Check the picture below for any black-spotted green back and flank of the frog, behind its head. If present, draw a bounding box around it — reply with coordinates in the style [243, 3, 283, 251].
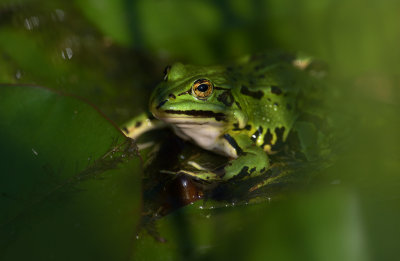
[228, 53, 318, 152]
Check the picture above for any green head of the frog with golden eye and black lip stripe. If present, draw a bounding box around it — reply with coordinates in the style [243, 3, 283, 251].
[150, 63, 247, 128]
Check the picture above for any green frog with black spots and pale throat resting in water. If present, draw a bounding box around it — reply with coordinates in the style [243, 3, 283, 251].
[122, 52, 324, 188]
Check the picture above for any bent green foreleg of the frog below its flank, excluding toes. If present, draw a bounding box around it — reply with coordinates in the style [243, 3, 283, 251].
[221, 133, 269, 180]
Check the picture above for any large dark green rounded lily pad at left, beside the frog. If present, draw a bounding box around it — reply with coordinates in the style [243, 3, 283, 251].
[0, 85, 141, 260]
